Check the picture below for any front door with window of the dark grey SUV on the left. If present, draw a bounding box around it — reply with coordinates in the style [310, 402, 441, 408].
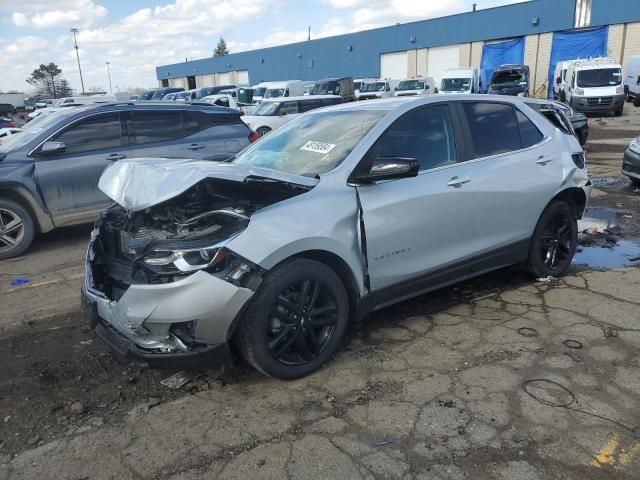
[35, 112, 128, 218]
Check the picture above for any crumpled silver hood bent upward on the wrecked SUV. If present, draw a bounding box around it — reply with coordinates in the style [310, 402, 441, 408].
[98, 158, 318, 212]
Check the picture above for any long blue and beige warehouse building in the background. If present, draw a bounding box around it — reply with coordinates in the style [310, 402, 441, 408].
[156, 0, 640, 96]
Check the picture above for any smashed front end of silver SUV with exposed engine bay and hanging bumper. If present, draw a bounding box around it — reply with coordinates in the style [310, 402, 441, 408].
[83, 159, 314, 368]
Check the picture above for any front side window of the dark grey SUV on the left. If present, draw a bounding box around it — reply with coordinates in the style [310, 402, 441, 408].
[54, 113, 122, 153]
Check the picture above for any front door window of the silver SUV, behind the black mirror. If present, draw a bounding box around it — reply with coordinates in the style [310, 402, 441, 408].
[370, 105, 457, 170]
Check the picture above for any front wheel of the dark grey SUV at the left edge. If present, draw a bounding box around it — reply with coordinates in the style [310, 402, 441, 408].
[0, 199, 35, 260]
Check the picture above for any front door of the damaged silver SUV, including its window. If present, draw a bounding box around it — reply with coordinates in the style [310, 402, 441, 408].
[357, 103, 473, 296]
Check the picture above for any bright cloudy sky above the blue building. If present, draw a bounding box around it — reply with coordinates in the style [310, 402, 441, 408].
[0, 0, 524, 92]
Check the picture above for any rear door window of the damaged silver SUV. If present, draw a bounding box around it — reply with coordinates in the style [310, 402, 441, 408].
[462, 102, 522, 158]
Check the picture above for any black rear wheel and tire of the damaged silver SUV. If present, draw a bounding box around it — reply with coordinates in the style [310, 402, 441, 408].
[527, 201, 578, 278]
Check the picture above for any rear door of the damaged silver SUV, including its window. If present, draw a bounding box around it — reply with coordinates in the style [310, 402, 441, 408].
[459, 101, 562, 271]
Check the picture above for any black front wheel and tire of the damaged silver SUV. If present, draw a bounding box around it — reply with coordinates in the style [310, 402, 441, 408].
[237, 258, 349, 380]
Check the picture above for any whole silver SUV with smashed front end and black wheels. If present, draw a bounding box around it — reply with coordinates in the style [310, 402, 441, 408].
[83, 95, 591, 379]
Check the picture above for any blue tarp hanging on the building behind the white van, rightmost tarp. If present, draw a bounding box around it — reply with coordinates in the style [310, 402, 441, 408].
[549, 26, 613, 98]
